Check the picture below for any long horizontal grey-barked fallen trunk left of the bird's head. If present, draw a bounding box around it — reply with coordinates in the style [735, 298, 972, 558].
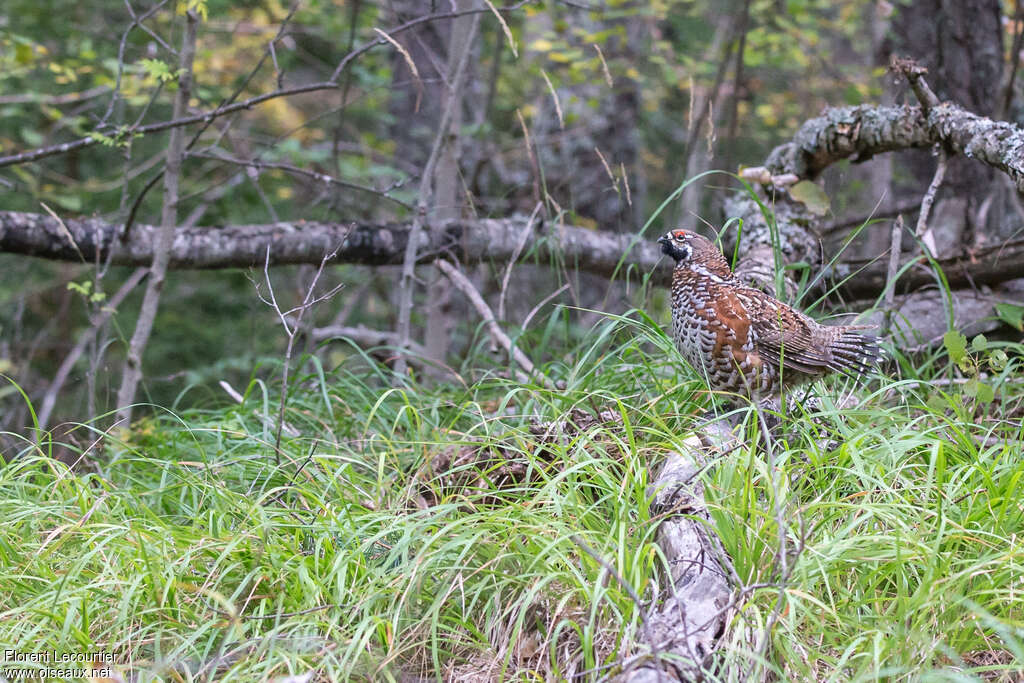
[0, 211, 672, 283]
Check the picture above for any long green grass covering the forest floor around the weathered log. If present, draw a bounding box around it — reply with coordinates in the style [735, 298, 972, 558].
[0, 318, 1024, 681]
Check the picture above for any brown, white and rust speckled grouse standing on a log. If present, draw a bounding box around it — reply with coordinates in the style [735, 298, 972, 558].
[658, 230, 882, 400]
